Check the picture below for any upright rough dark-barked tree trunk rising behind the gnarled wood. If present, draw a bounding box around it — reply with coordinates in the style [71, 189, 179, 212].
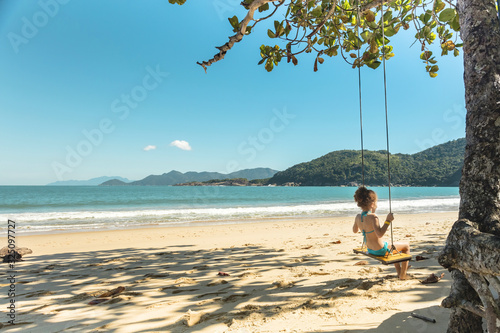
[443, 0, 500, 333]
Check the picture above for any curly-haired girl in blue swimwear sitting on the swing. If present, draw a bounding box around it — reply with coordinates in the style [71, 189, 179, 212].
[352, 186, 410, 280]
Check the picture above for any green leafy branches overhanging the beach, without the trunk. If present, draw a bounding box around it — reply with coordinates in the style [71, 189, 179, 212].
[173, 0, 462, 77]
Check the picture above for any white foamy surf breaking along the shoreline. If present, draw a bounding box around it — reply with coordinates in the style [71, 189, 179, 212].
[0, 197, 459, 231]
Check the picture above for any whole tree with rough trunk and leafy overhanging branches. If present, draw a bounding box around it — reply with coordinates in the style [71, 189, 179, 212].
[169, 0, 500, 333]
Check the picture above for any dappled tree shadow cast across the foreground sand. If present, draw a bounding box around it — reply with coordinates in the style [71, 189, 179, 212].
[0, 231, 450, 332]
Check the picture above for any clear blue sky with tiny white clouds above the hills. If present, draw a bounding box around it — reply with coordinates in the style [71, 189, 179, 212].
[0, 0, 465, 185]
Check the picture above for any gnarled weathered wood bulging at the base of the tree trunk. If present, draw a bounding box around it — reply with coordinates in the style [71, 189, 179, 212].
[438, 219, 500, 332]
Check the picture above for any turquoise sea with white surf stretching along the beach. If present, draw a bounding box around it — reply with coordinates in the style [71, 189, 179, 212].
[0, 186, 459, 234]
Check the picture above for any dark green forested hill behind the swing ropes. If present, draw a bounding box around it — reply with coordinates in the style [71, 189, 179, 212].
[269, 139, 465, 186]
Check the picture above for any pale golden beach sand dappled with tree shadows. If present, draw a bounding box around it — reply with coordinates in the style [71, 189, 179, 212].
[0, 213, 457, 333]
